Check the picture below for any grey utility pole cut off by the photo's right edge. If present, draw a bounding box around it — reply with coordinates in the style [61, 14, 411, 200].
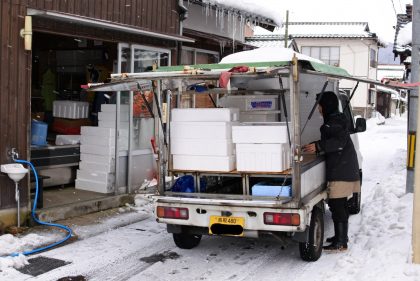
[407, 0, 420, 264]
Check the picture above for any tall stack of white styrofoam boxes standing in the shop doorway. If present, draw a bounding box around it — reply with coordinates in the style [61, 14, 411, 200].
[76, 104, 128, 193]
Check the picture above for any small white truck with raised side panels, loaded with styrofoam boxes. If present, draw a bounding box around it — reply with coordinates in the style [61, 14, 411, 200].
[88, 48, 404, 261]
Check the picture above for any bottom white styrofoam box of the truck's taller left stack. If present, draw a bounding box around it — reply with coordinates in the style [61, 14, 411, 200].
[172, 155, 235, 172]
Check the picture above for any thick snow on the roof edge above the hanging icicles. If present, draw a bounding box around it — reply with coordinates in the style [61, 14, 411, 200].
[202, 0, 286, 26]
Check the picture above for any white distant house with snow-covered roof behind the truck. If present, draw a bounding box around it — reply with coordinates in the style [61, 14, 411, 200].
[281, 22, 382, 117]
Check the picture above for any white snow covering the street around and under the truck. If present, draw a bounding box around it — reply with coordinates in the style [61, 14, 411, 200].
[0, 112, 420, 281]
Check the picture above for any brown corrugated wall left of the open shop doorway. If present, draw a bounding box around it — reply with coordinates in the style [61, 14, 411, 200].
[0, 0, 31, 209]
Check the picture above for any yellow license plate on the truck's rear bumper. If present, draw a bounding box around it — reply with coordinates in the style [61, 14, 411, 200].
[209, 216, 245, 236]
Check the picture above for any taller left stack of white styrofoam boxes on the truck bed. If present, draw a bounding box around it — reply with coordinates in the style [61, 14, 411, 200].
[170, 108, 239, 172]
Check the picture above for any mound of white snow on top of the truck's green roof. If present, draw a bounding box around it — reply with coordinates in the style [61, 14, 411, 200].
[220, 47, 324, 64]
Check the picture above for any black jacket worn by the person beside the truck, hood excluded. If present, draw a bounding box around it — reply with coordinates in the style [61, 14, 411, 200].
[316, 111, 360, 181]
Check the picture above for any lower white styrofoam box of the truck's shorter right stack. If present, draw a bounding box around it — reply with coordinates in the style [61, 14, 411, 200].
[236, 143, 290, 172]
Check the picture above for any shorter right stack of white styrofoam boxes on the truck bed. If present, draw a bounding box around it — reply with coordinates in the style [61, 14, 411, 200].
[232, 122, 290, 172]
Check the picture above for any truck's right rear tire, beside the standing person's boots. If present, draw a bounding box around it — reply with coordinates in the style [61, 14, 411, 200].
[299, 207, 324, 261]
